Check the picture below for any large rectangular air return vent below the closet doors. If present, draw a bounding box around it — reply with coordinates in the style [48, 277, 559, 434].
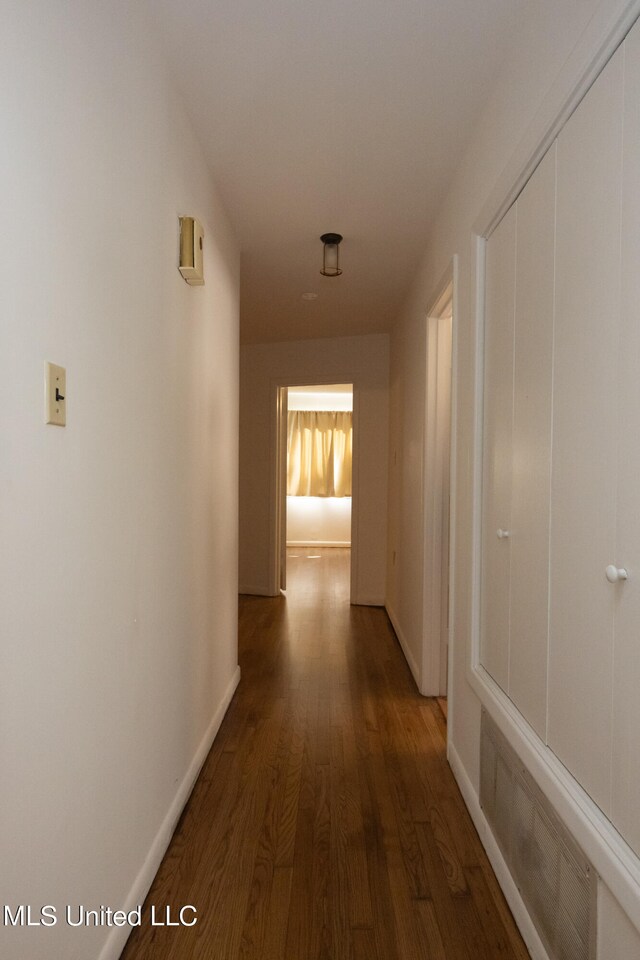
[480, 710, 597, 960]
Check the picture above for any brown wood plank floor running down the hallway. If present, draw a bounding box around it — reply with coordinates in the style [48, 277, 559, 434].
[122, 548, 529, 960]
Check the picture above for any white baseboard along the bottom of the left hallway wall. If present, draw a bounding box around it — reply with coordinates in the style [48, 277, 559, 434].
[98, 667, 240, 960]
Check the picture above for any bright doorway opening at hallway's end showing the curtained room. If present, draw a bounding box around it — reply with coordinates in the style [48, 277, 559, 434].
[278, 383, 354, 597]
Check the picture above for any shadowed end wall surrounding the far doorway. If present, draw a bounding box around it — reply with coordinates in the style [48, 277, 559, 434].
[239, 335, 389, 604]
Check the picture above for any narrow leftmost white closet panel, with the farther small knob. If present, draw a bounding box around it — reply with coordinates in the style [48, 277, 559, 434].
[480, 206, 516, 690]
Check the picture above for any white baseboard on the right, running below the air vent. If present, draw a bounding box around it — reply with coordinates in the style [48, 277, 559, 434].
[447, 742, 549, 960]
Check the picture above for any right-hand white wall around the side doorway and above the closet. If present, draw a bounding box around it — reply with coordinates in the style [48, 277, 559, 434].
[387, 0, 638, 958]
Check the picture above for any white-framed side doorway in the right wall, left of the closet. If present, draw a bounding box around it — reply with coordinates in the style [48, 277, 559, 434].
[421, 263, 455, 704]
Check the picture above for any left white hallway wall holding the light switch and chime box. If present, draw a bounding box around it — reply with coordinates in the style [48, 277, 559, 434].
[0, 0, 239, 960]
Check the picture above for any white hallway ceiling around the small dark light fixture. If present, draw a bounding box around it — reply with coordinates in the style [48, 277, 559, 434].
[152, 0, 531, 342]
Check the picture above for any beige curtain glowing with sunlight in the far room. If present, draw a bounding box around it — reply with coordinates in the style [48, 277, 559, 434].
[287, 410, 353, 497]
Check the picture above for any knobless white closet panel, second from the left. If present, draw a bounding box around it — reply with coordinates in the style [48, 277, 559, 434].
[509, 145, 556, 739]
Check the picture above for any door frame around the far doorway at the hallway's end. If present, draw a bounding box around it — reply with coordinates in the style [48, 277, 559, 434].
[268, 373, 360, 604]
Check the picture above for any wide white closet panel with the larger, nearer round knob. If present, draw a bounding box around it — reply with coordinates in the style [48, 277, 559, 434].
[548, 50, 623, 812]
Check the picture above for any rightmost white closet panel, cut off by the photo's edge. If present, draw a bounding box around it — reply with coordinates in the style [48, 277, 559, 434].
[611, 18, 640, 854]
